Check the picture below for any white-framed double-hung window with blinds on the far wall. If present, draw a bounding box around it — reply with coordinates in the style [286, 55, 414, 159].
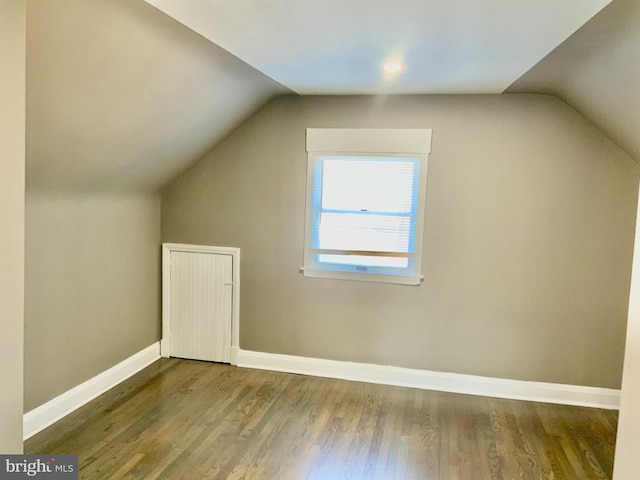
[303, 128, 431, 285]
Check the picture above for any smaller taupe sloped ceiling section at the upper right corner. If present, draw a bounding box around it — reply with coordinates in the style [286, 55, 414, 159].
[507, 0, 640, 163]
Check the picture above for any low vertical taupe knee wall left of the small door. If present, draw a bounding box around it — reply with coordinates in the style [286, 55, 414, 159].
[24, 191, 160, 411]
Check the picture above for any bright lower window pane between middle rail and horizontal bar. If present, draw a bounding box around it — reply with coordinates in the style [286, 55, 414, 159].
[316, 213, 411, 252]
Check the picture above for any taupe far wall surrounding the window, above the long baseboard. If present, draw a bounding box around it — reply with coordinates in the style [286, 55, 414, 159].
[162, 95, 638, 388]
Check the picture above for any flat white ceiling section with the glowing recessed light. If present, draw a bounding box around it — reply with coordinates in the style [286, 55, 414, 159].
[145, 0, 611, 94]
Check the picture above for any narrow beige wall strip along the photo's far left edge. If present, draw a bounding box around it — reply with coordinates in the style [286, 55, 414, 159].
[0, 0, 26, 453]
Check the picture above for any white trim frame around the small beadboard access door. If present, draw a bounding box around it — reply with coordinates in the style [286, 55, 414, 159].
[160, 243, 240, 365]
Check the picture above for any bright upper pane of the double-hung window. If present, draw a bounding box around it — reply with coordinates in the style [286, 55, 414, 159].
[322, 157, 418, 213]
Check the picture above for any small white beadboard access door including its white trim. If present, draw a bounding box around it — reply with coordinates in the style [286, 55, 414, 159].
[161, 244, 240, 363]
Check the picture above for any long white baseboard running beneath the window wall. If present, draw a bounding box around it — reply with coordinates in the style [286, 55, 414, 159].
[237, 350, 620, 410]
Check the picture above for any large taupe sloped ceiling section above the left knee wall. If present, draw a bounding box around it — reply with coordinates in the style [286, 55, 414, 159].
[27, 0, 288, 191]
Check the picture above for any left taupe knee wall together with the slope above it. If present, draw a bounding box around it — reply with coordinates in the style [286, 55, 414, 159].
[20, 0, 287, 411]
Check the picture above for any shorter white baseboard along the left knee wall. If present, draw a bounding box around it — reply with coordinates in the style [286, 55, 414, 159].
[23, 342, 160, 440]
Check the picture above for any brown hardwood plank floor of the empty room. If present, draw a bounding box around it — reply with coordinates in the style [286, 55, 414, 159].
[25, 359, 618, 480]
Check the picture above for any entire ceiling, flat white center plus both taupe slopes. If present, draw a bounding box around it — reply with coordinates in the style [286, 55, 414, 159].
[27, 0, 640, 195]
